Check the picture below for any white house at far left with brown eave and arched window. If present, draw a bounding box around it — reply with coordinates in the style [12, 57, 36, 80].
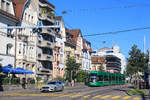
[0, 0, 19, 67]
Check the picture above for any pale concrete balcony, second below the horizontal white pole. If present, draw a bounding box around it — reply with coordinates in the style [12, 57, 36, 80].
[38, 40, 54, 49]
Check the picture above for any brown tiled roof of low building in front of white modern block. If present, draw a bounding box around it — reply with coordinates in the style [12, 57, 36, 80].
[91, 56, 106, 64]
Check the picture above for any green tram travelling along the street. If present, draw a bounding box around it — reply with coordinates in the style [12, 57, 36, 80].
[86, 71, 125, 86]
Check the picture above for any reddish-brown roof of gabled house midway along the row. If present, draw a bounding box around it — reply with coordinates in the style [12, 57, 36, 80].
[66, 29, 82, 44]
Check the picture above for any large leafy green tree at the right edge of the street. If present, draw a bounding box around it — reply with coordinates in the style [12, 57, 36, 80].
[126, 45, 148, 80]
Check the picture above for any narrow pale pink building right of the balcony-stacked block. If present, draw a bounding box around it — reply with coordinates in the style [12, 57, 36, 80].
[52, 16, 65, 79]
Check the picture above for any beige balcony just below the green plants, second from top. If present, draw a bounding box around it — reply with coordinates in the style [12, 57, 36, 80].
[39, 12, 55, 24]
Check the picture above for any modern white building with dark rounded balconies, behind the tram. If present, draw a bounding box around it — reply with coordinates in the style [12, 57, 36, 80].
[92, 46, 126, 73]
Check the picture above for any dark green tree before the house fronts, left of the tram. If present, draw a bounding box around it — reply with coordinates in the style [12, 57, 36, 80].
[66, 57, 81, 82]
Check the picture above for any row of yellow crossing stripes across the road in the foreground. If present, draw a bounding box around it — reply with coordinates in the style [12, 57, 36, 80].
[1, 93, 142, 100]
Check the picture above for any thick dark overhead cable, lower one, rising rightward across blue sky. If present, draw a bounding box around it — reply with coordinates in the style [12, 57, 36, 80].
[83, 27, 150, 37]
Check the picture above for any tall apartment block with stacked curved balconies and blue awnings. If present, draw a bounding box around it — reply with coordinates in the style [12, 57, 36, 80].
[37, 0, 55, 80]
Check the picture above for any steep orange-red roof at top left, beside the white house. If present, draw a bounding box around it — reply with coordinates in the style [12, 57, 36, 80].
[12, 0, 27, 20]
